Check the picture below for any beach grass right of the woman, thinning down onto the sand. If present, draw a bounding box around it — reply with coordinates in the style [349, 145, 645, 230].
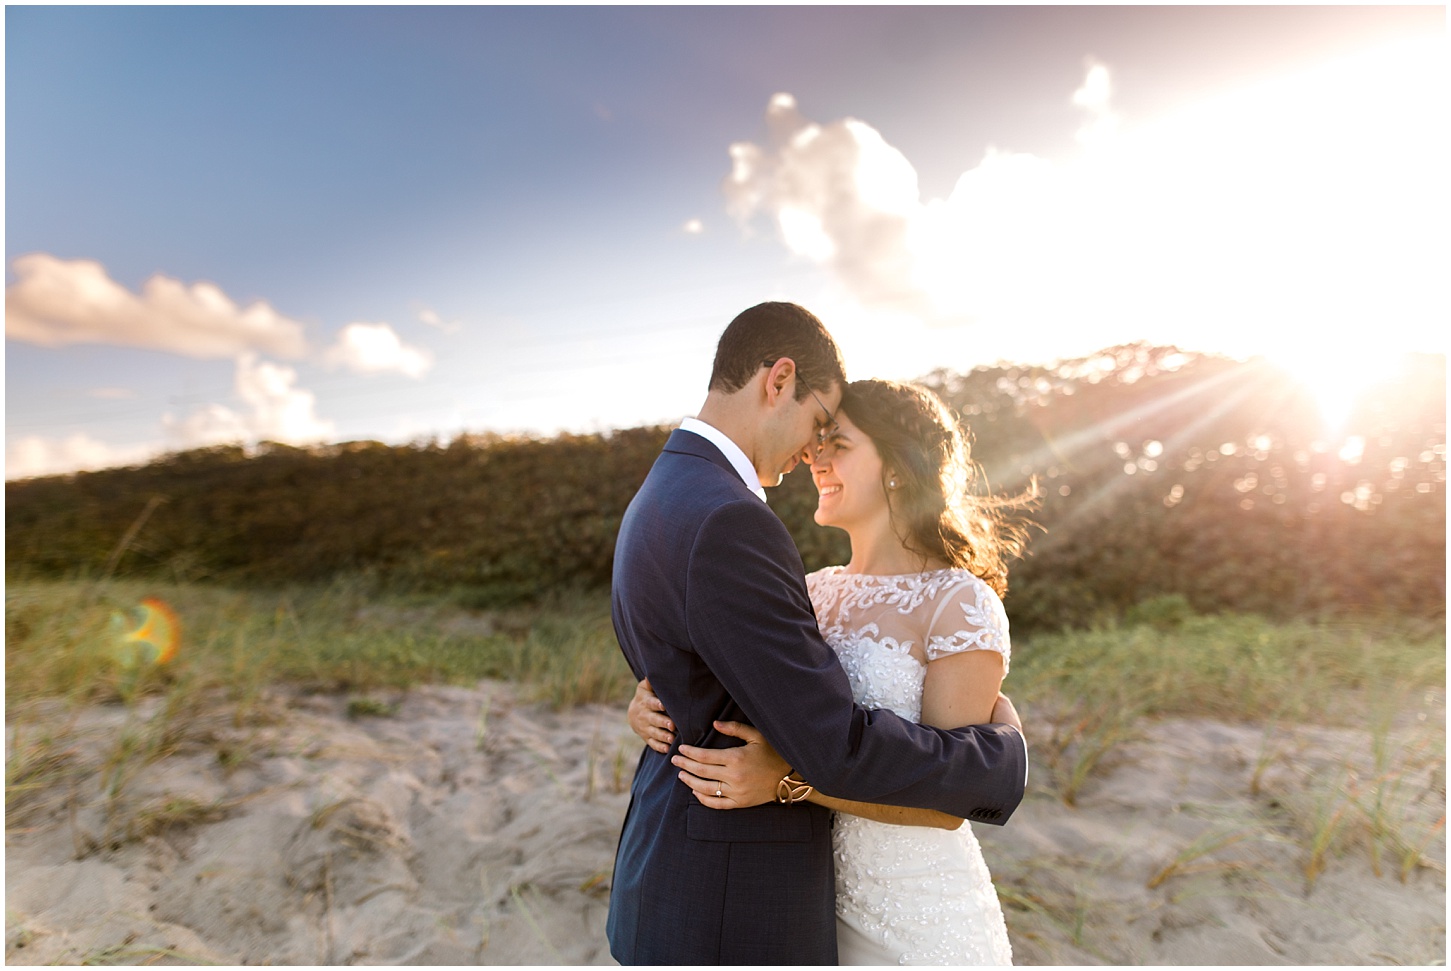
[1006, 600, 1445, 888]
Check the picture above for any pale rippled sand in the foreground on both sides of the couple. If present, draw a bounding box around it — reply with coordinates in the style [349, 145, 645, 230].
[6, 682, 1445, 965]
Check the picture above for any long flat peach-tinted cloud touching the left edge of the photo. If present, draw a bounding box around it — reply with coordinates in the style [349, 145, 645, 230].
[4, 253, 306, 357]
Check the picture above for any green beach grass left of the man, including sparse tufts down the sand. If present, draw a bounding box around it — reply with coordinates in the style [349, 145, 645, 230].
[6, 581, 634, 852]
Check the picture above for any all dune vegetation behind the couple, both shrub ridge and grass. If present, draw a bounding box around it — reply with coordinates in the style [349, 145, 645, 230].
[6, 347, 1445, 962]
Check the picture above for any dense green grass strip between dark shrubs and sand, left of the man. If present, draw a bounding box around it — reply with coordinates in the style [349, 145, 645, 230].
[6, 581, 634, 716]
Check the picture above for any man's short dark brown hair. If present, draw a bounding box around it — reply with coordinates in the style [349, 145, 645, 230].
[710, 302, 846, 401]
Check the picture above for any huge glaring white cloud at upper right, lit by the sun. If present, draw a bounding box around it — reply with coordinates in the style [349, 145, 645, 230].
[723, 35, 1451, 360]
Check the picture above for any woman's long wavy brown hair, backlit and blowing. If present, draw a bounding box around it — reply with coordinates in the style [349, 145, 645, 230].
[842, 380, 1039, 597]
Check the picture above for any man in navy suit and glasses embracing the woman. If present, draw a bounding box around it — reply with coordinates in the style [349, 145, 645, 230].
[608, 303, 1027, 964]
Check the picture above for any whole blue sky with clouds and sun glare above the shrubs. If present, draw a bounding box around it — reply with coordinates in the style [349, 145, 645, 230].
[4, 6, 1451, 478]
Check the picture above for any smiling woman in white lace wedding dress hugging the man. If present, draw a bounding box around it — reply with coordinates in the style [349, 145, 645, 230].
[630, 380, 1032, 965]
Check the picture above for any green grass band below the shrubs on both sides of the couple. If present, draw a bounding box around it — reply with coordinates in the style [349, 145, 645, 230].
[6, 581, 1445, 766]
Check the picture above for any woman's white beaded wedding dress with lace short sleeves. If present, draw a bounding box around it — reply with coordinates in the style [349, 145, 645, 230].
[807, 566, 1013, 965]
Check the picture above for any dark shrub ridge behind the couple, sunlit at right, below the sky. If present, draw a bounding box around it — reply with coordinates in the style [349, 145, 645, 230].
[6, 344, 1447, 630]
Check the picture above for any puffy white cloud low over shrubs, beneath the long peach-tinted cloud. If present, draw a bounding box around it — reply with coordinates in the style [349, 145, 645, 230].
[161, 354, 335, 448]
